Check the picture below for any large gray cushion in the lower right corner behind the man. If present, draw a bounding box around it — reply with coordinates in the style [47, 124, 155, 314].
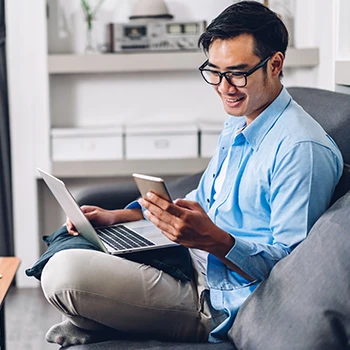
[229, 192, 350, 350]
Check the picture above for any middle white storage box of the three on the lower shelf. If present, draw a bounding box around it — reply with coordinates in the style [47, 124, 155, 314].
[125, 123, 198, 159]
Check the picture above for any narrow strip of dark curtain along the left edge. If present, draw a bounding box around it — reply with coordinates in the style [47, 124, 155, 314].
[0, 0, 14, 256]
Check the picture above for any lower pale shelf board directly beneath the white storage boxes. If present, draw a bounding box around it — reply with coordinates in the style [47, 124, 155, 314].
[52, 158, 210, 178]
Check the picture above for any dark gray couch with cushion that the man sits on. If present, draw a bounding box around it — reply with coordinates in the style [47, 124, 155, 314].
[69, 87, 350, 350]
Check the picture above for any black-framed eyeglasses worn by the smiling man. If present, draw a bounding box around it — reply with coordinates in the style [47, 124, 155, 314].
[198, 56, 272, 88]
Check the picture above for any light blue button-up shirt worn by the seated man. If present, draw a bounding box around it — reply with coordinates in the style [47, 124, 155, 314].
[186, 88, 343, 341]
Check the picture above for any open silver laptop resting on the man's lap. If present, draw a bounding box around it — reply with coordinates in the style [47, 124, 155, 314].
[37, 168, 177, 255]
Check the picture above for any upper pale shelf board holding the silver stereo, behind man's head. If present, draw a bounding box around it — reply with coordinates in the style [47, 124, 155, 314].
[48, 47, 319, 74]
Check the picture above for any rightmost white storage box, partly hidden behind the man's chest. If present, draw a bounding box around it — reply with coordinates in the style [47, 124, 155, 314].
[198, 122, 223, 158]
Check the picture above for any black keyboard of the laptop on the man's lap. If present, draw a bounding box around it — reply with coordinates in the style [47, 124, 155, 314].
[96, 225, 155, 250]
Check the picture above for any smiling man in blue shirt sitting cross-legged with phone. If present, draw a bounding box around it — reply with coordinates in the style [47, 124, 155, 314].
[42, 1, 343, 346]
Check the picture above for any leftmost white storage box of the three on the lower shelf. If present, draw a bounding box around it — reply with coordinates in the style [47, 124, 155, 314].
[51, 126, 123, 161]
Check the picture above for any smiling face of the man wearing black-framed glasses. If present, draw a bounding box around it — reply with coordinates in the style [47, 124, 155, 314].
[208, 34, 281, 123]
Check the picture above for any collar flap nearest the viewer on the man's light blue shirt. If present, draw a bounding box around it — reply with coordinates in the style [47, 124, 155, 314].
[242, 87, 292, 151]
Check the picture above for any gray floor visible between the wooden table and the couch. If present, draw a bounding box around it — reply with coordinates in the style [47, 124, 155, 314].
[5, 287, 61, 350]
